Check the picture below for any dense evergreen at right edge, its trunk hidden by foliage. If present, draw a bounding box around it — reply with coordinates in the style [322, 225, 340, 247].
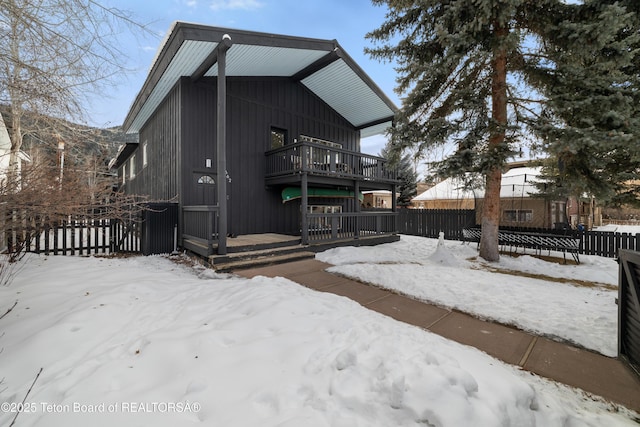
[535, 1, 640, 206]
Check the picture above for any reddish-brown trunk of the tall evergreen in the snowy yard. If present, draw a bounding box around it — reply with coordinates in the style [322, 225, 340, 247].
[480, 22, 508, 262]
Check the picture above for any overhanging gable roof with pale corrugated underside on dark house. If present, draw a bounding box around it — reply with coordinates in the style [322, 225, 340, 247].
[123, 22, 397, 137]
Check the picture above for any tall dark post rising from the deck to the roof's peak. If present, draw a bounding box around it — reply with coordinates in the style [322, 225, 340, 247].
[218, 34, 232, 255]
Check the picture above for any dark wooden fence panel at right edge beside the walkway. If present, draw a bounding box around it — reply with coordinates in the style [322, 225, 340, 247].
[618, 250, 640, 375]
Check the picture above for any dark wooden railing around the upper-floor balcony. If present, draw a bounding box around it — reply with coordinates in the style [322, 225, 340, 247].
[265, 141, 397, 184]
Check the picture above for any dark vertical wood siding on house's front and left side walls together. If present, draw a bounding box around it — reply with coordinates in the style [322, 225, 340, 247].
[124, 77, 360, 235]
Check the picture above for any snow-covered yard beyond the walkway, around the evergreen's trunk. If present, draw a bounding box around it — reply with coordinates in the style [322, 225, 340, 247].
[317, 236, 618, 356]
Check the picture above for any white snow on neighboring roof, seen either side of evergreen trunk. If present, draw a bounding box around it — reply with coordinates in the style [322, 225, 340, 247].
[413, 167, 541, 201]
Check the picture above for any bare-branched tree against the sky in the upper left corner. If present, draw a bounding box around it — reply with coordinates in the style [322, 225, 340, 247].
[0, 0, 152, 183]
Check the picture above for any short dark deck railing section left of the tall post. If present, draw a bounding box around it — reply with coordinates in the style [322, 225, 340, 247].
[182, 206, 218, 255]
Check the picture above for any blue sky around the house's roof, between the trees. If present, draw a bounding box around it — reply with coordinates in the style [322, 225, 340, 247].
[90, 0, 400, 154]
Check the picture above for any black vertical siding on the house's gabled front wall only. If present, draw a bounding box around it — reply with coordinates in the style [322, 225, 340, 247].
[181, 78, 359, 235]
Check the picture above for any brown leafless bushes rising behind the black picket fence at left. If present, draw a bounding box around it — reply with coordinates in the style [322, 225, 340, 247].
[0, 148, 148, 263]
